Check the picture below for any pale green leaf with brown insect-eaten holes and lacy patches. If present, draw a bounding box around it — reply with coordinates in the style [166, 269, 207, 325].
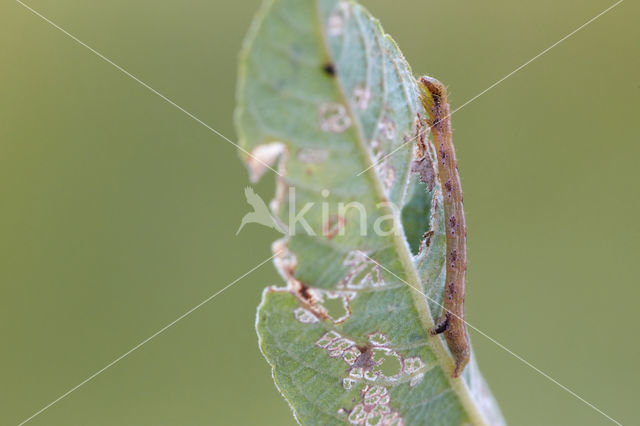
[236, 0, 503, 425]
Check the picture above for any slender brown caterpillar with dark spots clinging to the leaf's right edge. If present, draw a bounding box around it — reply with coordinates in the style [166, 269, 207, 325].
[418, 77, 471, 377]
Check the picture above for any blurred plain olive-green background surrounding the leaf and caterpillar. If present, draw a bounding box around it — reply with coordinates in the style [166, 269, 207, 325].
[0, 0, 640, 425]
